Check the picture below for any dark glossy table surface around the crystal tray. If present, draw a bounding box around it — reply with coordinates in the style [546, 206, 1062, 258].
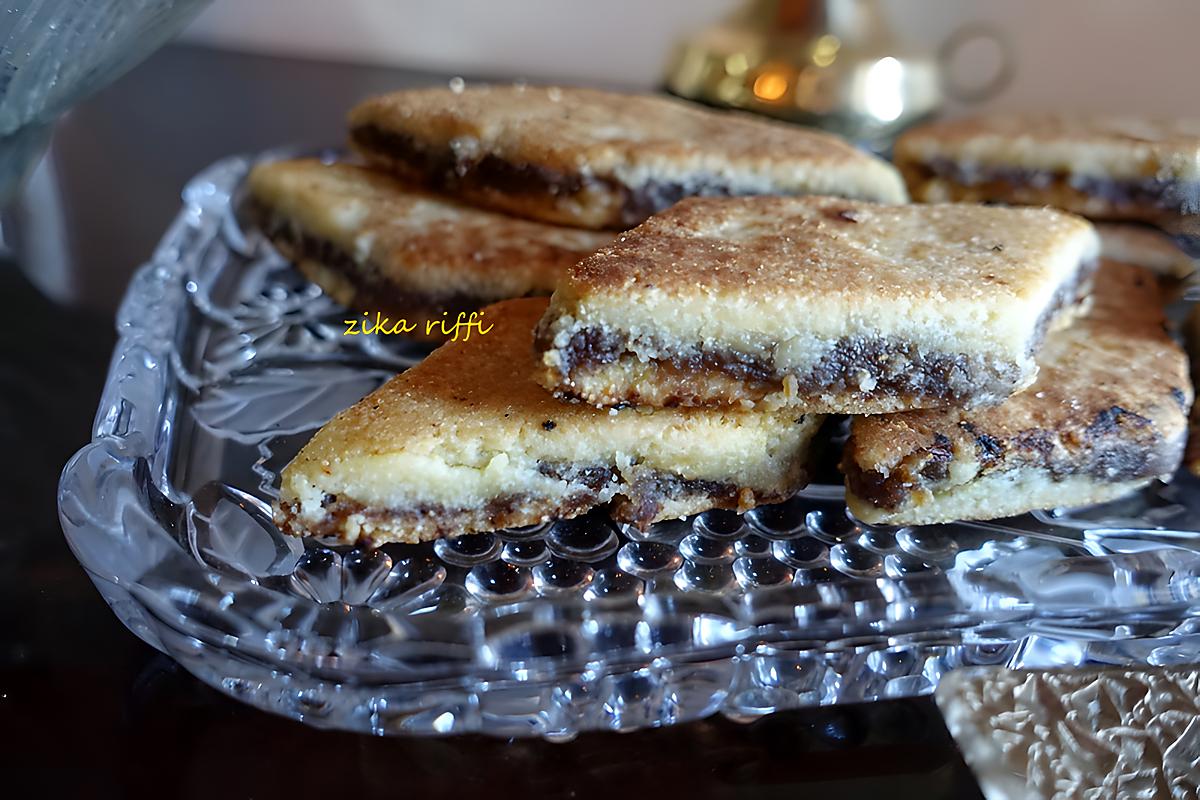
[0, 46, 980, 800]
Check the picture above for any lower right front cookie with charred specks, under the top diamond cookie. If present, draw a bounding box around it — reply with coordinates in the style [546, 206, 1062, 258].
[842, 261, 1193, 524]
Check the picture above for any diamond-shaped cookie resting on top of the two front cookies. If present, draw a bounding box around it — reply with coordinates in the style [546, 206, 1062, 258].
[538, 197, 1099, 414]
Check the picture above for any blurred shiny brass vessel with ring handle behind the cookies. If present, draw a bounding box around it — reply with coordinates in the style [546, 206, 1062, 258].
[666, 0, 1013, 151]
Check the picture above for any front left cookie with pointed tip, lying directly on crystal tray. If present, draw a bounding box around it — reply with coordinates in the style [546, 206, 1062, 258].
[276, 299, 821, 545]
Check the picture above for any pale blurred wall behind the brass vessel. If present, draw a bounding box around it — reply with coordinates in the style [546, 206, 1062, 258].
[184, 0, 1200, 115]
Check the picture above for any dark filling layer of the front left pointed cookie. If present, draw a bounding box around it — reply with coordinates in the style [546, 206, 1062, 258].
[277, 463, 758, 546]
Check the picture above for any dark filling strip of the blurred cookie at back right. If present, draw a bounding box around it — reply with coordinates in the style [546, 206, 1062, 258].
[922, 158, 1200, 213]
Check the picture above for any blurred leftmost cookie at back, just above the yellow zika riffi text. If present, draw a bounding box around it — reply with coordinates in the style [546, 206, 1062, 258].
[246, 158, 612, 338]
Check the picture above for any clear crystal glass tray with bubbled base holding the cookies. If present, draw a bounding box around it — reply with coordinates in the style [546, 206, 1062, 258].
[59, 157, 1200, 739]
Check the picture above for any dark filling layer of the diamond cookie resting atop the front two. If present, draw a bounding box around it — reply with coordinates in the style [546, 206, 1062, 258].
[536, 257, 1096, 402]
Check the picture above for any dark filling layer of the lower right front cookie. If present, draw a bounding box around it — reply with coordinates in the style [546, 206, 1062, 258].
[841, 405, 1183, 511]
